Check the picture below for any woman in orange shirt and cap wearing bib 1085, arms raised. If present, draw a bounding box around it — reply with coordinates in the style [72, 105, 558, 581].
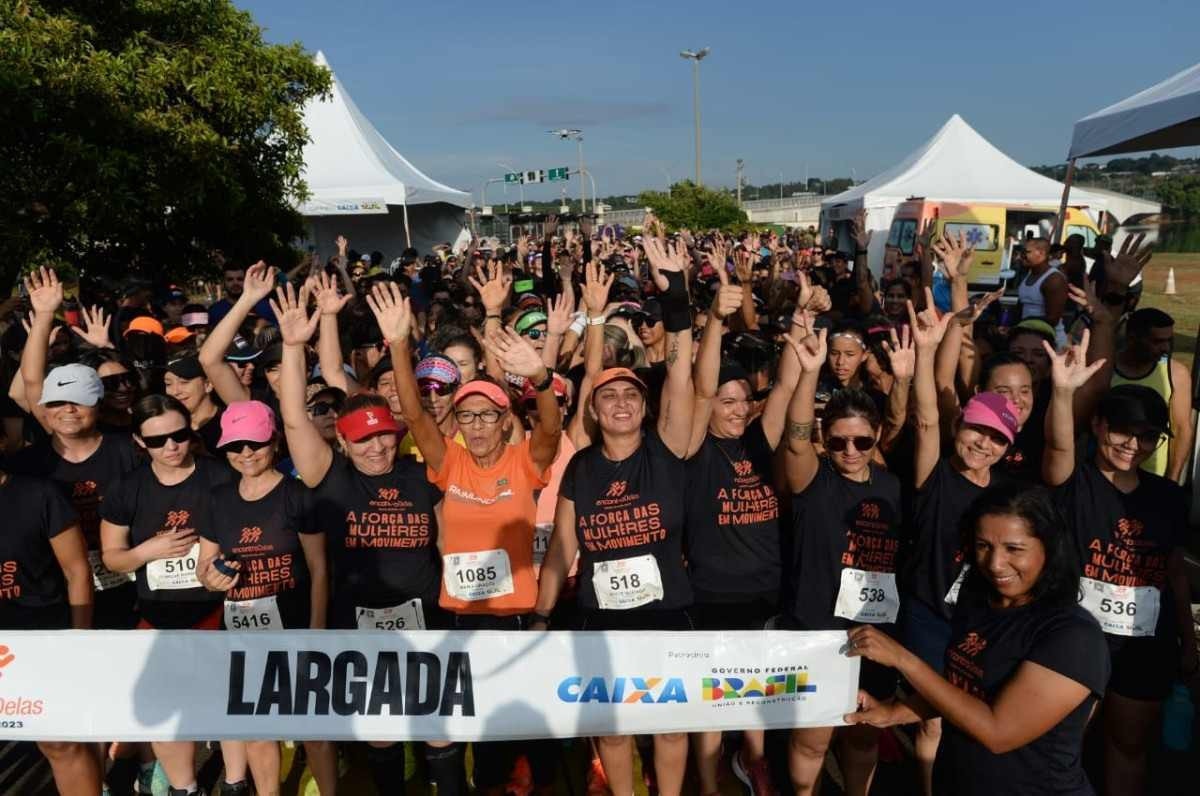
[367, 279, 563, 794]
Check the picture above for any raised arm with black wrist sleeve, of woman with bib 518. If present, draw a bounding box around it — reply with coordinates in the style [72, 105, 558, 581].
[644, 238, 695, 459]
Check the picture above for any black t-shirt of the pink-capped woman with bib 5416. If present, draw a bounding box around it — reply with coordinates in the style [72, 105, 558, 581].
[200, 478, 319, 627]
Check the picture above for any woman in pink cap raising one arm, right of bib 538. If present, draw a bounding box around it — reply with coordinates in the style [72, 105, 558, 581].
[892, 288, 1020, 794]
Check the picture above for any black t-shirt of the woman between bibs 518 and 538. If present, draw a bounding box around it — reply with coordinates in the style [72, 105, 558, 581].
[685, 421, 781, 603]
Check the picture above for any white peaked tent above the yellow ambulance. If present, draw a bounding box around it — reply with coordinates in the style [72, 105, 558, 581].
[821, 114, 1105, 269]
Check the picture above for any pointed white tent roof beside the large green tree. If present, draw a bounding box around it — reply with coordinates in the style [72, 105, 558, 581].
[300, 52, 470, 216]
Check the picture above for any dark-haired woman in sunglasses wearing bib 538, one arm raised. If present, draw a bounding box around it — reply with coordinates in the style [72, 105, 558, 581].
[781, 325, 900, 796]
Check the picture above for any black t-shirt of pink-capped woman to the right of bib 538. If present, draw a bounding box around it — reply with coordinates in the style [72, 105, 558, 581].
[902, 457, 1007, 621]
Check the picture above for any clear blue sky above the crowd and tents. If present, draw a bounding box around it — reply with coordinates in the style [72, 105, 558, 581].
[241, 0, 1200, 204]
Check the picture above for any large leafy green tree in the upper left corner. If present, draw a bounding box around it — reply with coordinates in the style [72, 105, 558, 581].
[0, 0, 330, 292]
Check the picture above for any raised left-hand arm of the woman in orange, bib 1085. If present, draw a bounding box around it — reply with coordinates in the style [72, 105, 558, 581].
[367, 282, 446, 471]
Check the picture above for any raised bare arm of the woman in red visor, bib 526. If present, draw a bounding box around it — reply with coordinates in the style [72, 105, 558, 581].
[270, 283, 334, 489]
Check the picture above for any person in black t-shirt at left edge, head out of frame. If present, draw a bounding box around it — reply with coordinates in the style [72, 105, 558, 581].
[0, 471, 101, 796]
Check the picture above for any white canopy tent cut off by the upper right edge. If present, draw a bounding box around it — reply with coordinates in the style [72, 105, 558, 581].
[1067, 64, 1200, 160]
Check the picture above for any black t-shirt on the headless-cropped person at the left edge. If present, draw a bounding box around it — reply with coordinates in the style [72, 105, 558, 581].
[0, 474, 79, 628]
